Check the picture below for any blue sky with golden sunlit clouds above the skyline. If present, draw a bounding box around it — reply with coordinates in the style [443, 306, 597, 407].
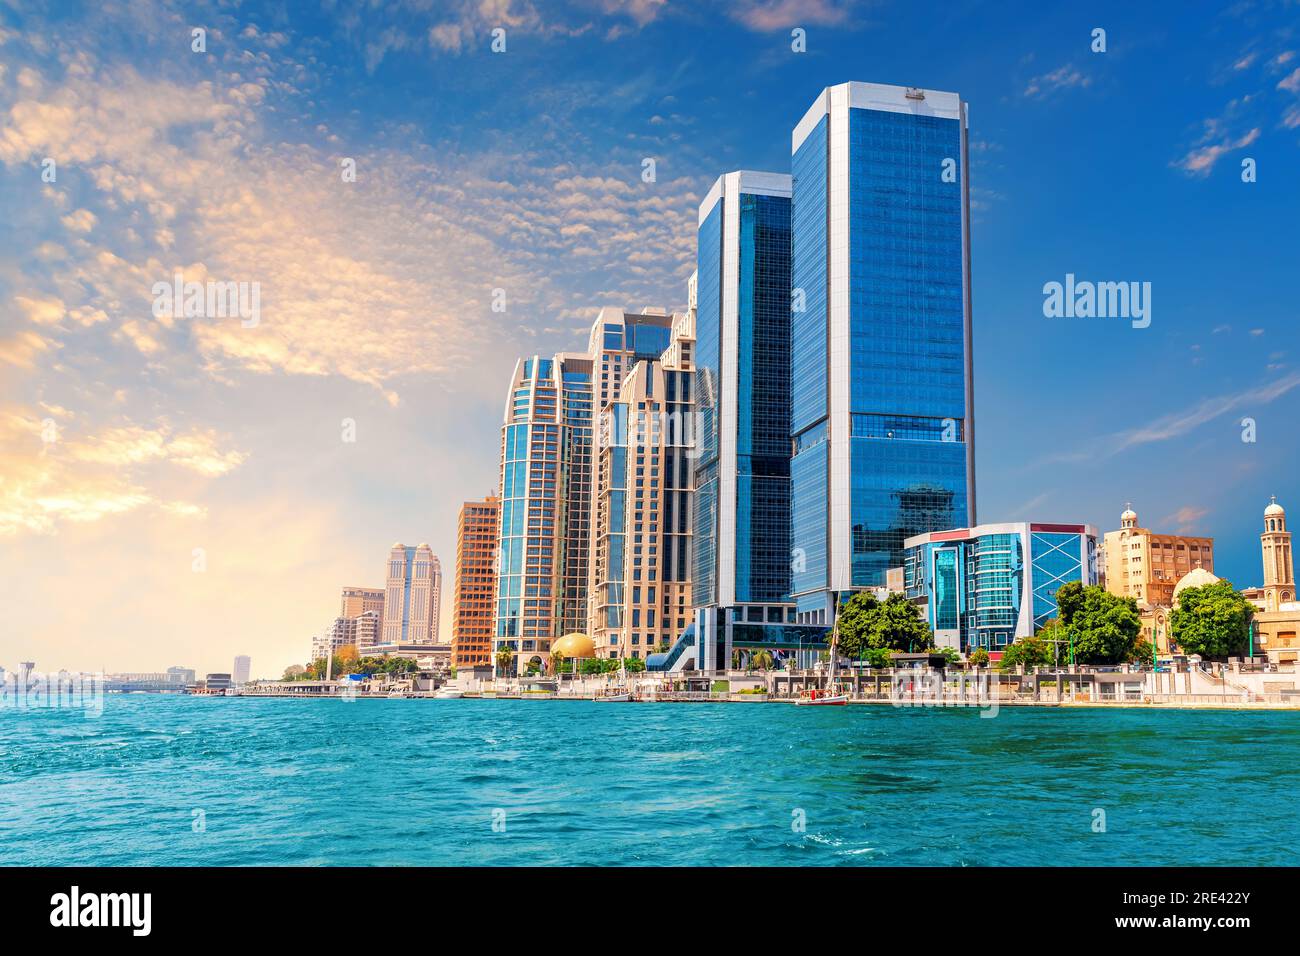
[0, 0, 1300, 676]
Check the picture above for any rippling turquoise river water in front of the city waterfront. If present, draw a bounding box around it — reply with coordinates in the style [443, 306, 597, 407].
[0, 696, 1300, 866]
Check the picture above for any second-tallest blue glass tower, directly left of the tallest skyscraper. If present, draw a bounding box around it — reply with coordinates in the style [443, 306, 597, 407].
[693, 170, 790, 619]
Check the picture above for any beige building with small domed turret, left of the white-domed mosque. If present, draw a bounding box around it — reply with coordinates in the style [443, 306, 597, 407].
[1104, 507, 1214, 654]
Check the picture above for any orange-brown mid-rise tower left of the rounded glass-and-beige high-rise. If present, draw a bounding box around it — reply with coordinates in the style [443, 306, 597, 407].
[451, 494, 501, 667]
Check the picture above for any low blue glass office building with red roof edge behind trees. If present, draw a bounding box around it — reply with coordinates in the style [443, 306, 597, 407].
[902, 522, 1097, 654]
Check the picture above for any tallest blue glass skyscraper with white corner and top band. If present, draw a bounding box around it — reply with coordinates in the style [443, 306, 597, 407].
[780, 83, 975, 623]
